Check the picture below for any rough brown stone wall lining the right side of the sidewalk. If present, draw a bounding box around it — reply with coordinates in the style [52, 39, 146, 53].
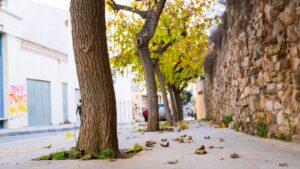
[205, 0, 300, 141]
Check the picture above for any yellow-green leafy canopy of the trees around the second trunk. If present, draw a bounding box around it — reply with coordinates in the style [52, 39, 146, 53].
[107, 0, 213, 88]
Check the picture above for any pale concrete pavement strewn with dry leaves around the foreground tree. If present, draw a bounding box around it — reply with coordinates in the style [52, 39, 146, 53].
[0, 122, 300, 169]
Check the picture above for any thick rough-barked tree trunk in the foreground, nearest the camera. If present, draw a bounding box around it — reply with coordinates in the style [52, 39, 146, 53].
[70, 0, 119, 155]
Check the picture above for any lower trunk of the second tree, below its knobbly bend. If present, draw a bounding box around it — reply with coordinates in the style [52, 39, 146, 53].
[138, 44, 159, 131]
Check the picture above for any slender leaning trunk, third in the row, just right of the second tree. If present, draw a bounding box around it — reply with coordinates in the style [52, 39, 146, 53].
[154, 63, 172, 125]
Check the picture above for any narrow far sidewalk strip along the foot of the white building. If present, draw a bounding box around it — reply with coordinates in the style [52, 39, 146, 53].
[0, 124, 79, 136]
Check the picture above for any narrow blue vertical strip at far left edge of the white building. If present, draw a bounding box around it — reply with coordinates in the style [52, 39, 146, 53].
[0, 33, 4, 128]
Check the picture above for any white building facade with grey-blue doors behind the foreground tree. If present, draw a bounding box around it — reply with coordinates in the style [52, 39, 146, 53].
[0, 0, 132, 128]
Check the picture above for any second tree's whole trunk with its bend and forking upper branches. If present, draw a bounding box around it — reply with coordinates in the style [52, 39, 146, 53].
[108, 0, 167, 131]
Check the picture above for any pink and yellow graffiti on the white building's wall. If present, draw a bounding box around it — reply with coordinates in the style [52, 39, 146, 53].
[9, 86, 27, 117]
